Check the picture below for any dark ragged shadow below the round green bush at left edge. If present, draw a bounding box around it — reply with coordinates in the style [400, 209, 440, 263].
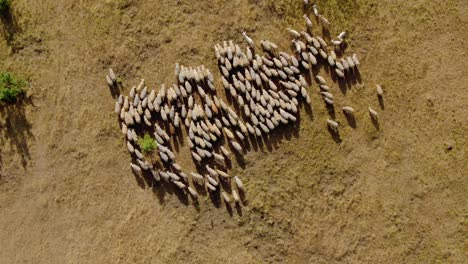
[0, 97, 34, 168]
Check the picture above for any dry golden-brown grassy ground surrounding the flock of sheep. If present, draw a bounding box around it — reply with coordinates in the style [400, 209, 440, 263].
[0, 0, 468, 263]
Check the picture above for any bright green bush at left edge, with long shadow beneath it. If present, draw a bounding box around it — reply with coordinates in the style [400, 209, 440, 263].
[0, 71, 27, 103]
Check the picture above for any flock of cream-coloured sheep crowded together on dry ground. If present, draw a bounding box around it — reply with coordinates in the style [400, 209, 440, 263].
[106, 6, 383, 206]
